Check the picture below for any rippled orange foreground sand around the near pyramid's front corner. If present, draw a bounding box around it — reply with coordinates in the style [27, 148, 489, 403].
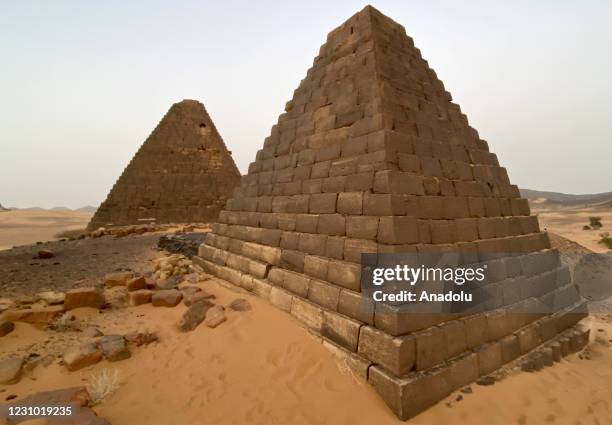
[0, 281, 612, 425]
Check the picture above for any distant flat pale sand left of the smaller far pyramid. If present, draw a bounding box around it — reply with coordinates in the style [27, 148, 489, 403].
[0, 210, 92, 250]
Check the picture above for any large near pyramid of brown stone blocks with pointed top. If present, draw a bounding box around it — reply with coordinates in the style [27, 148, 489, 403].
[195, 6, 586, 419]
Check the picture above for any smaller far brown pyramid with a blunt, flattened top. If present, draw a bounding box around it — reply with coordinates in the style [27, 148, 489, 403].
[88, 100, 240, 230]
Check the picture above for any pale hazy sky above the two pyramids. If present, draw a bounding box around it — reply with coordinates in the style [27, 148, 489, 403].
[0, 0, 612, 208]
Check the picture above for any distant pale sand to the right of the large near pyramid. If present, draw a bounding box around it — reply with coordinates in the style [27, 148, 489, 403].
[532, 208, 612, 252]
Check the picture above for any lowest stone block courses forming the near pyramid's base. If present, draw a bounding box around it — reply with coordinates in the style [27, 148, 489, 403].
[193, 256, 590, 420]
